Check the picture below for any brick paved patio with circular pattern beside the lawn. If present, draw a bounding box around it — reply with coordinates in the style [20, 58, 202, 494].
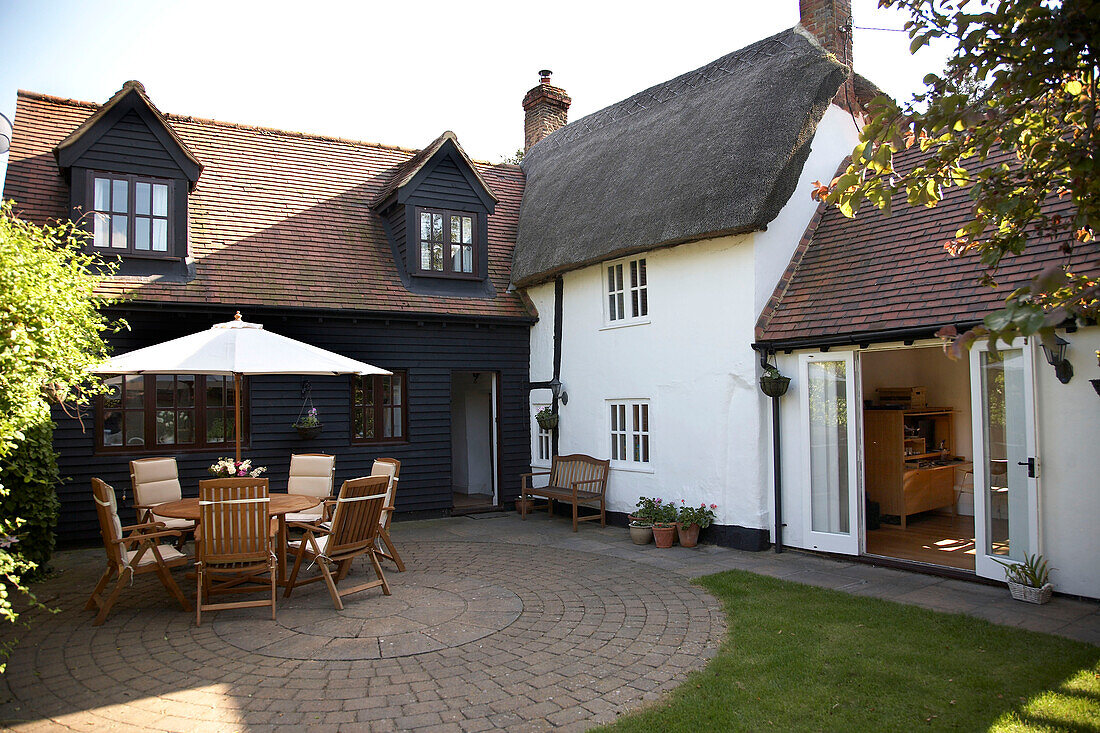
[0, 515, 1100, 732]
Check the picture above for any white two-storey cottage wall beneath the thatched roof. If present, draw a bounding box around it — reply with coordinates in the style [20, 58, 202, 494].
[528, 106, 858, 528]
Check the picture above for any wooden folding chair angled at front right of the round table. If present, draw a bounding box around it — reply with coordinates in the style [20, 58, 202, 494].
[285, 475, 391, 611]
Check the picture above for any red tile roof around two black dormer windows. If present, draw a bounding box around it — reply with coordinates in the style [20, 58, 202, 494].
[4, 91, 530, 318]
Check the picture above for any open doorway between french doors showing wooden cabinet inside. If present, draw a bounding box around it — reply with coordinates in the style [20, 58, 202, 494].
[860, 347, 975, 572]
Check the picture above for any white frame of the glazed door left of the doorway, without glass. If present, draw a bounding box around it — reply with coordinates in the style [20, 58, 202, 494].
[799, 350, 864, 555]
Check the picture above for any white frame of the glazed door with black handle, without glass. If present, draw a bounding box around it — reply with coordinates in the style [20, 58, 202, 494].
[970, 339, 1040, 580]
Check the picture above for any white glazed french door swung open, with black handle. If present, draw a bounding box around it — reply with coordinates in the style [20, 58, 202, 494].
[970, 339, 1040, 580]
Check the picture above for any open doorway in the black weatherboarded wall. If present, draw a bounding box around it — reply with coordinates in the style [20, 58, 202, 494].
[451, 372, 498, 514]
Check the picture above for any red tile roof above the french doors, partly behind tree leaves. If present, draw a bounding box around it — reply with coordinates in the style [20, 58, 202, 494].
[756, 149, 1100, 342]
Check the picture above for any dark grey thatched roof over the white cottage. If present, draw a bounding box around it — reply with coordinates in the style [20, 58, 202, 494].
[512, 26, 848, 286]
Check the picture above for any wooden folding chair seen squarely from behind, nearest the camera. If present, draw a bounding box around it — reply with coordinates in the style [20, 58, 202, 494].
[195, 478, 276, 625]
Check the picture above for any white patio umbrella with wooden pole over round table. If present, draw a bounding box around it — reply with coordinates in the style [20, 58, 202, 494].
[95, 311, 392, 460]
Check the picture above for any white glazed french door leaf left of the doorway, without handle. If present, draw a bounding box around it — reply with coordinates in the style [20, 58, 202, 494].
[799, 351, 861, 555]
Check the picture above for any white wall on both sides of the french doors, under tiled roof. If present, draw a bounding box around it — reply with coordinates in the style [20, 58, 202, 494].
[766, 327, 1100, 598]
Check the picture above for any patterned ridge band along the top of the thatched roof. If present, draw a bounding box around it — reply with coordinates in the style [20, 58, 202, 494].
[537, 25, 809, 154]
